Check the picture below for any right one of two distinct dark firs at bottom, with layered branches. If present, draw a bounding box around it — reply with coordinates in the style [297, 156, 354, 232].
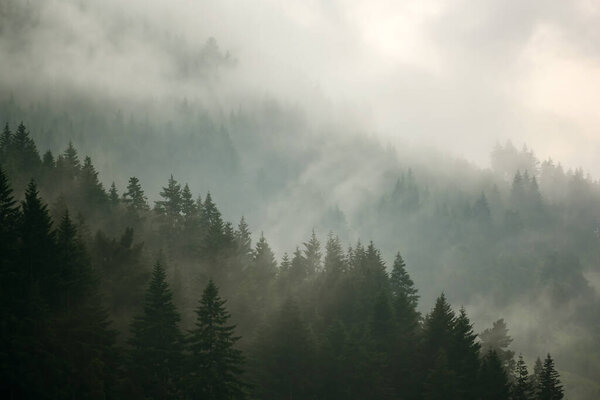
[186, 280, 246, 400]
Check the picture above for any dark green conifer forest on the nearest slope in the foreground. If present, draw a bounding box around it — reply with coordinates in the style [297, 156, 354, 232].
[0, 123, 564, 400]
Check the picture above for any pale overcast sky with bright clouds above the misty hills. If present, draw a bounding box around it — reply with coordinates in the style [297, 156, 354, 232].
[0, 0, 600, 177]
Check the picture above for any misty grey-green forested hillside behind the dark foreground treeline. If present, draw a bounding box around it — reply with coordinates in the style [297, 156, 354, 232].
[2, 94, 600, 398]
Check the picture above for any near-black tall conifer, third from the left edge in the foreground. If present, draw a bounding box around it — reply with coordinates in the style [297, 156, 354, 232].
[54, 212, 118, 399]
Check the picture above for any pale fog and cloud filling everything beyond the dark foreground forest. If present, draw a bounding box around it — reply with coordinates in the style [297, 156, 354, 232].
[0, 0, 600, 399]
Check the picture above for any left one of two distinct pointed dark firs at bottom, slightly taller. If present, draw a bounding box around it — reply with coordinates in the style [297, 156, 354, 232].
[129, 261, 183, 399]
